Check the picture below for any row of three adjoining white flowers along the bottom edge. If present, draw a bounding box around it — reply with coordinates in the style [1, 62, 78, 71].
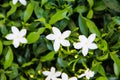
[43, 67, 94, 80]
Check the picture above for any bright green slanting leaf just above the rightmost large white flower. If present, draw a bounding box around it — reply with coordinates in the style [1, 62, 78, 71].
[84, 17, 101, 37]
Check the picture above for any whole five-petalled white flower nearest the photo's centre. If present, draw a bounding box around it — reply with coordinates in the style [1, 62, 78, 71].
[46, 27, 71, 51]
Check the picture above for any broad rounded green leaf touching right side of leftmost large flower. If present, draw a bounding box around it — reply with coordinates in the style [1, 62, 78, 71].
[27, 32, 40, 44]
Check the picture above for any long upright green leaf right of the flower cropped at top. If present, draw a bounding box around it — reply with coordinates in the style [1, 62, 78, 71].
[23, 3, 34, 22]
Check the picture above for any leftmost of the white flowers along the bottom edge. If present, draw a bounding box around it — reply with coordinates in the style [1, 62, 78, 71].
[43, 67, 61, 80]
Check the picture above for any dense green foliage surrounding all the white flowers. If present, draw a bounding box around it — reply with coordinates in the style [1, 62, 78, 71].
[0, 0, 120, 80]
